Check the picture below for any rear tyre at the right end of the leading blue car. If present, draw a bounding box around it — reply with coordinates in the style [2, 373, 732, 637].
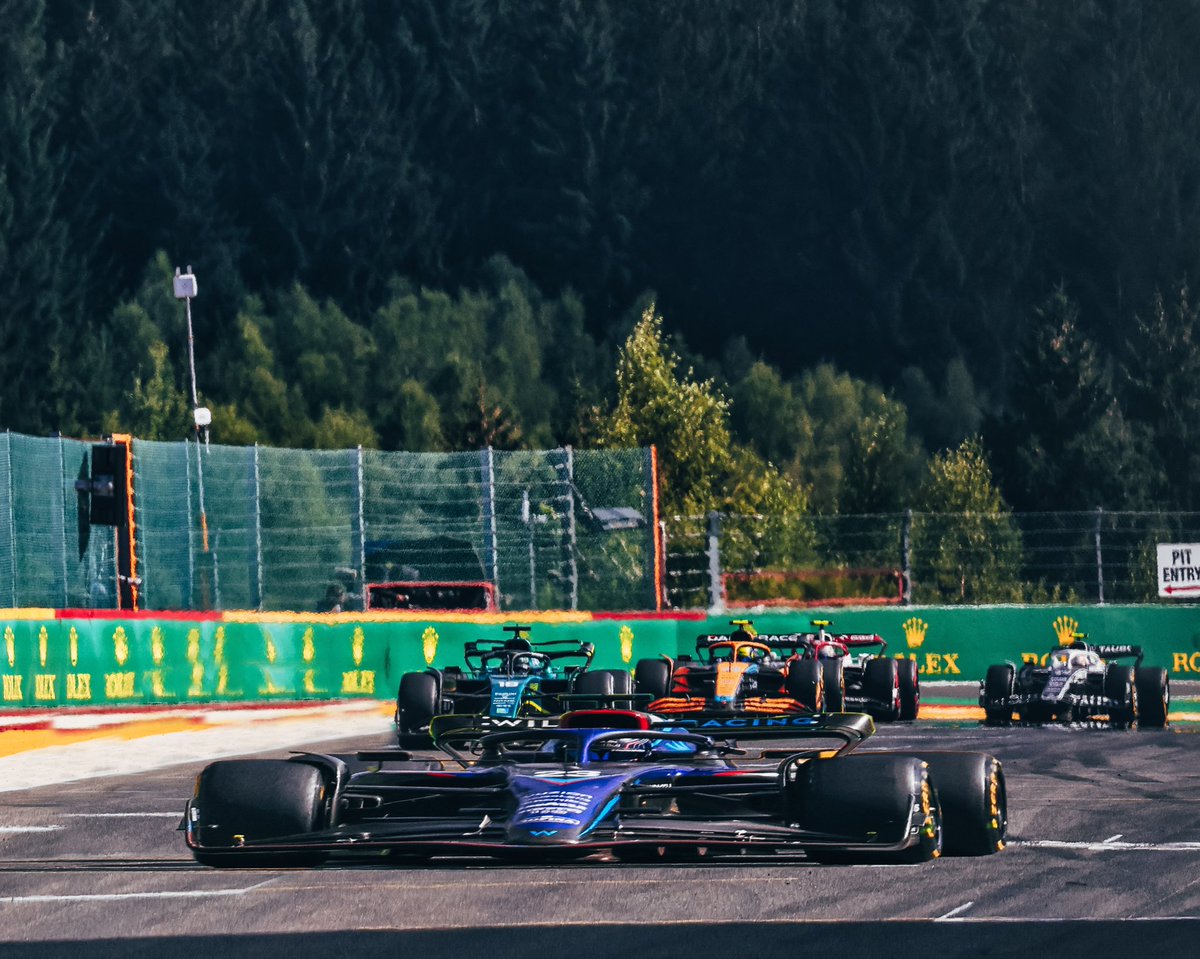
[918, 753, 1008, 856]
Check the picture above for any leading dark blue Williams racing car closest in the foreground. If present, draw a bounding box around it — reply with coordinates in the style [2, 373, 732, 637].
[180, 709, 1007, 867]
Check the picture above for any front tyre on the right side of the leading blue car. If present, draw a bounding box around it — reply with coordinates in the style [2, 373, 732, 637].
[785, 753, 943, 863]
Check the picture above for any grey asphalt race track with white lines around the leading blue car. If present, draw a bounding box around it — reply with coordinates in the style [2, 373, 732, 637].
[0, 721, 1200, 959]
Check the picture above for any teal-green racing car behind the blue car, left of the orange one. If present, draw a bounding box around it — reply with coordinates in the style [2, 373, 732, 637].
[396, 625, 632, 743]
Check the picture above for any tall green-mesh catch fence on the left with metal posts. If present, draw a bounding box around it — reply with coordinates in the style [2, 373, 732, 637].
[0, 433, 656, 610]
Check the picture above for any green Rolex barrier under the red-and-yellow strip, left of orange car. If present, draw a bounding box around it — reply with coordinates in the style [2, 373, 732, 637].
[0, 611, 677, 709]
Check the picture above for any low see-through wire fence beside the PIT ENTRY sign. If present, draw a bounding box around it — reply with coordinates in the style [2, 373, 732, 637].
[662, 509, 1200, 609]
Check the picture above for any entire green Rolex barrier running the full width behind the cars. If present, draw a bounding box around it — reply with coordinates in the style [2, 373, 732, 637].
[0, 606, 1200, 709]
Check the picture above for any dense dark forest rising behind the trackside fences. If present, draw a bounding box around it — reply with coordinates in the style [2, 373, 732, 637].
[0, 0, 1200, 513]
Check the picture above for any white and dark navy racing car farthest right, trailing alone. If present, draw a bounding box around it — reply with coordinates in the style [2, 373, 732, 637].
[979, 634, 1171, 729]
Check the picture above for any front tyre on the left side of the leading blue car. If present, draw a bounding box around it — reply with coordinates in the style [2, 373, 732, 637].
[191, 760, 326, 867]
